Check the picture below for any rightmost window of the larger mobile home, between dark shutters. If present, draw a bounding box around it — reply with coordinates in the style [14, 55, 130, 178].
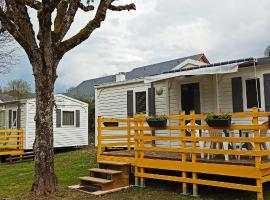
[246, 79, 261, 108]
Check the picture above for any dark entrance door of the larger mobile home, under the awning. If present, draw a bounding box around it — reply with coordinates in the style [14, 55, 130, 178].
[181, 83, 201, 114]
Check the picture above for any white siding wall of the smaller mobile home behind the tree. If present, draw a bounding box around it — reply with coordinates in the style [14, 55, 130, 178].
[25, 95, 88, 149]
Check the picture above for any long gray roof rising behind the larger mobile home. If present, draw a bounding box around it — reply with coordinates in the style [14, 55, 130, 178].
[66, 54, 204, 98]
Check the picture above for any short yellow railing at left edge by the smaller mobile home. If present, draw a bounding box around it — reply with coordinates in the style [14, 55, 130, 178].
[0, 129, 23, 155]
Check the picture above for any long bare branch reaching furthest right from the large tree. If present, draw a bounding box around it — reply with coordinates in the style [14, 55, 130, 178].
[59, 0, 136, 56]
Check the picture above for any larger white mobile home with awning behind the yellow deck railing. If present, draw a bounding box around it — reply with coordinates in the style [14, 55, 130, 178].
[95, 57, 270, 146]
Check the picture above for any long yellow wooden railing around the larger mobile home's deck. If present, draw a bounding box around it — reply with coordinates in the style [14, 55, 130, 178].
[98, 108, 270, 199]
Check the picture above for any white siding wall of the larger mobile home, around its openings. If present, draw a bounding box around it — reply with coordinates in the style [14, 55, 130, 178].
[96, 66, 270, 146]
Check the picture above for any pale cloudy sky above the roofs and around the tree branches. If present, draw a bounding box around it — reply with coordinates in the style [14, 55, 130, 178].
[0, 0, 270, 93]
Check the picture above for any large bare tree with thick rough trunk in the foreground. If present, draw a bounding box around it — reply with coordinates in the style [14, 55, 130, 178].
[0, 0, 136, 195]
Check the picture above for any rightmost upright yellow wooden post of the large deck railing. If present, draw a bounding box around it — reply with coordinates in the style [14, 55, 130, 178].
[252, 108, 263, 200]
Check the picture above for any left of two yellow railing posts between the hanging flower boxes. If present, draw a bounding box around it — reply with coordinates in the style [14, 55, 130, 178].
[179, 112, 188, 195]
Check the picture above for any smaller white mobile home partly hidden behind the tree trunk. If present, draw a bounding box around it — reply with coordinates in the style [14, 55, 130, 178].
[0, 94, 88, 150]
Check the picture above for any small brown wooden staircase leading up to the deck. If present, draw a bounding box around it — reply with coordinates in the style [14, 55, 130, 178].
[70, 161, 130, 195]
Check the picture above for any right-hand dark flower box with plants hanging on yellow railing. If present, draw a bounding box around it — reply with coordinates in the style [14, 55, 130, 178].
[205, 113, 232, 127]
